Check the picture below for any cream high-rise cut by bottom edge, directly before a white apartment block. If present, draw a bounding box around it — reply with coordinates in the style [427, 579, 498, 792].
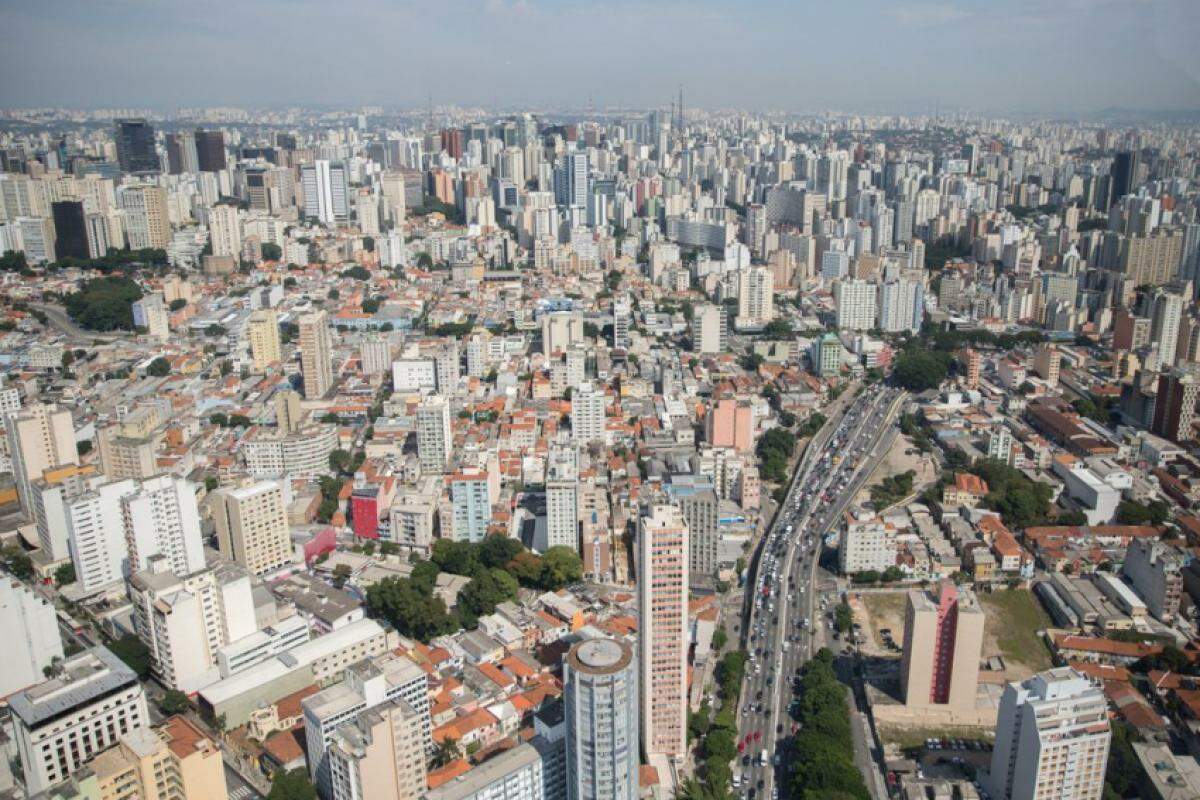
[328, 700, 426, 800]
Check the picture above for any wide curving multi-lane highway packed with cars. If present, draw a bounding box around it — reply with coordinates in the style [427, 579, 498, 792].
[734, 387, 904, 800]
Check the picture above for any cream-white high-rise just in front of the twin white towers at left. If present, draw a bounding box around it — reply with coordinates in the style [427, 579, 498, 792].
[128, 557, 258, 692]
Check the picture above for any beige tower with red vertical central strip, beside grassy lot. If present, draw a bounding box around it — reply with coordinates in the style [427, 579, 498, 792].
[900, 582, 984, 712]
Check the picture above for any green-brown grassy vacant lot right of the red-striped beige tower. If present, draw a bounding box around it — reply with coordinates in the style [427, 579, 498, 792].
[979, 589, 1054, 680]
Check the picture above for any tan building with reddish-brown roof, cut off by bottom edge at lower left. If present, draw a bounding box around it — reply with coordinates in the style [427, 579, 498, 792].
[88, 716, 229, 800]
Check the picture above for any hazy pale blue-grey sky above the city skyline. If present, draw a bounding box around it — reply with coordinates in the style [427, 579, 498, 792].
[0, 0, 1200, 113]
